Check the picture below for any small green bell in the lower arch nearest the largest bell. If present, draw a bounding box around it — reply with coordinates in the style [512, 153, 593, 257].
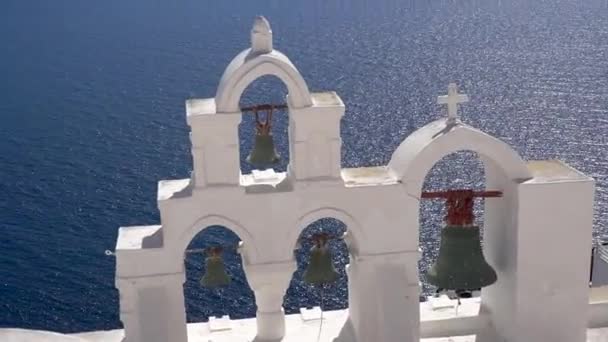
[304, 235, 338, 285]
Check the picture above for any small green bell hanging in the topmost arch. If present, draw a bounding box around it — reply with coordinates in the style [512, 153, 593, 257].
[247, 108, 280, 167]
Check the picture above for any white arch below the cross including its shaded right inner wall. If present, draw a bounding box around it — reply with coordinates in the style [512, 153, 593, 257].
[389, 120, 532, 306]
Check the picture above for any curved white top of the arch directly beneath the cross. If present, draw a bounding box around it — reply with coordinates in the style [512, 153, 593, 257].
[389, 120, 532, 197]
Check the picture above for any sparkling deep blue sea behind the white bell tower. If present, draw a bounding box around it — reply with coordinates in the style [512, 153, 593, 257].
[0, 0, 608, 332]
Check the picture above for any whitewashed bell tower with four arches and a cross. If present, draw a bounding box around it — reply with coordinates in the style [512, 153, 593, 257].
[111, 17, 594, 342]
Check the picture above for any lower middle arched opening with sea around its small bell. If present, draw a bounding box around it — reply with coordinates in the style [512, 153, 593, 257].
[283, 217, 349, 314]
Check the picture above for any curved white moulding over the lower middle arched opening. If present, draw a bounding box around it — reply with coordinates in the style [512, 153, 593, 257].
[282, 207, 366, 257]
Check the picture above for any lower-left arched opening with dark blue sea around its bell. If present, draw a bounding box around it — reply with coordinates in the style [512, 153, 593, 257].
[184, 226, 256, 323]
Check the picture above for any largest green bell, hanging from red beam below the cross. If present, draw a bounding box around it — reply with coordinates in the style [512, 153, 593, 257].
[426, 225, 497, 290]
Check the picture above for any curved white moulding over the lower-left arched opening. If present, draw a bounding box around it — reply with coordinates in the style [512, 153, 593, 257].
[177, 215, 259, 261]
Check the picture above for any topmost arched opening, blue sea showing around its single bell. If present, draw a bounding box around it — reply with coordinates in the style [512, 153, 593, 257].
[239, 75, 289, 174]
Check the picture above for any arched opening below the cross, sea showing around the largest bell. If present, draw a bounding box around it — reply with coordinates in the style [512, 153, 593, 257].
[418, 151, 490, 295]
